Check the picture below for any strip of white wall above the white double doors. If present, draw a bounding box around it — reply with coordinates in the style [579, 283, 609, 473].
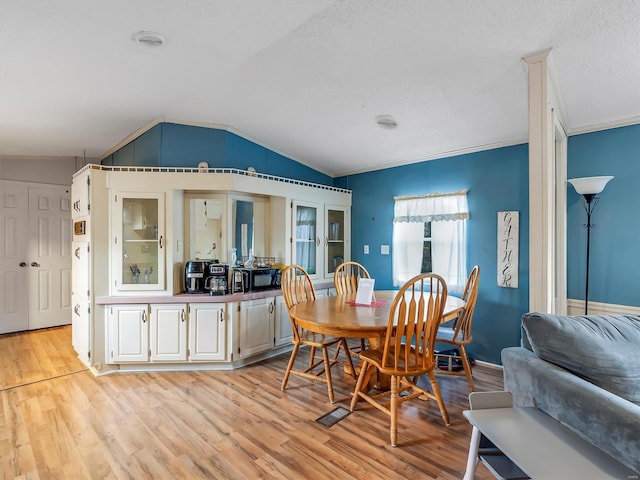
[0, 156, 90, 185]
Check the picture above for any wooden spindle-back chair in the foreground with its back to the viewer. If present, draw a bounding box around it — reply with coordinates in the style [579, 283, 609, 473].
[351, 273, 449, 447]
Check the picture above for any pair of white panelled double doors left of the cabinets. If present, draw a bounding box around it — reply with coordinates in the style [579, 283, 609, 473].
[0, 180, 72, 334]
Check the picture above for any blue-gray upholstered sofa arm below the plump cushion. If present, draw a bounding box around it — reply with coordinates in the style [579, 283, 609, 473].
[502, 347, 640, 472]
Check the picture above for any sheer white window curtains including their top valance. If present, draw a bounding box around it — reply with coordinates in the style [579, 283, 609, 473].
[393, 190, 469, 293]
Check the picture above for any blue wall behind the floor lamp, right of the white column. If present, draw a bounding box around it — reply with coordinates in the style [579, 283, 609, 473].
[567, 125, 640, 307]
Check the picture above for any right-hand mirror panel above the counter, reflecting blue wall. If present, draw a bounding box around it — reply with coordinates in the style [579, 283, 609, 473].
[231, 197, 268, 261]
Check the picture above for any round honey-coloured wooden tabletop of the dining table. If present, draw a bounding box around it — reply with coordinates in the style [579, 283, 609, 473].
[289, 290, 465, 339]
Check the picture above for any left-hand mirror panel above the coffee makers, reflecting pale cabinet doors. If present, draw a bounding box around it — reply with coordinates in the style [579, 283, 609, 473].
[188, 195, 226, 262]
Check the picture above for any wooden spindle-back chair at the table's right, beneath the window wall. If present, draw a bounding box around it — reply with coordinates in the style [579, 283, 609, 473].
[436, 265, 480, 392]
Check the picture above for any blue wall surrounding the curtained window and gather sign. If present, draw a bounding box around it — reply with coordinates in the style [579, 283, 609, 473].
[336, 145, 529, 364]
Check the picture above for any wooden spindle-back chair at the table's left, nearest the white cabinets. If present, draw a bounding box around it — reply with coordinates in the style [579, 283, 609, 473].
[281, 265, 355, 403]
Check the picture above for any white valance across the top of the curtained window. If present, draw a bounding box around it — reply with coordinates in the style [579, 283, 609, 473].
[393, 190, 469, 223]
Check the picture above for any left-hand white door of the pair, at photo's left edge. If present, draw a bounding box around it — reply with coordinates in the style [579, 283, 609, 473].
[0, 181, 30, 334]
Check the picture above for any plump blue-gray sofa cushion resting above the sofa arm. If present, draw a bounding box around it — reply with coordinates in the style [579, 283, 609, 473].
[522, 312, 640, 405]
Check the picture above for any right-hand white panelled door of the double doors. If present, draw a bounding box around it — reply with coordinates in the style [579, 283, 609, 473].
[28, 186, 73, 330]
